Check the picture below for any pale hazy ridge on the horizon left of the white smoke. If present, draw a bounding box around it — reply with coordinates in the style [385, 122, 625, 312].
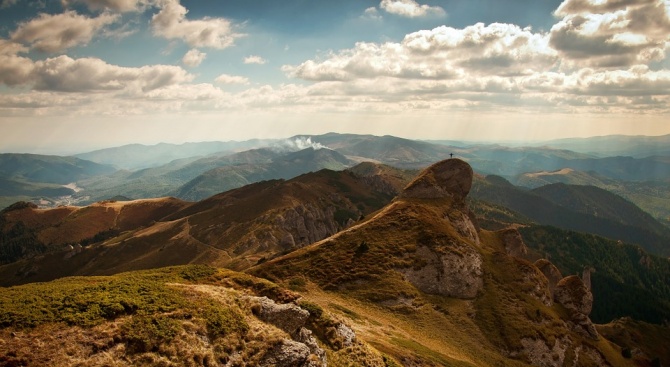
[75, 139, 273, 170]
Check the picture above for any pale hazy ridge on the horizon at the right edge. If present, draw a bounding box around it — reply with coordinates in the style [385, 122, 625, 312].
[541, 135, 670, 158]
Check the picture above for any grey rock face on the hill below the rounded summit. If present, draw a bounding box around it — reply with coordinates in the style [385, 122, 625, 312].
[401, 244, 484, 299]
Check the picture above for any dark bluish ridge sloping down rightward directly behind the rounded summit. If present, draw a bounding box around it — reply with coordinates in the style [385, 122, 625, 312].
[471, 176, 670, 256]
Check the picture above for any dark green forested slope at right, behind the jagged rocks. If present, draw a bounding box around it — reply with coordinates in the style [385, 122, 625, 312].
[519, 225, 670, 324]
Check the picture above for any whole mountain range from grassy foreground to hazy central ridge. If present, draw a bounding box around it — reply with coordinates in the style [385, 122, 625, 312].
[0, 134, 670, 366]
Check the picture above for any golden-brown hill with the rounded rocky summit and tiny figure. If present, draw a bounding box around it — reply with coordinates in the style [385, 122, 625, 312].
[250, 159, 652, 366]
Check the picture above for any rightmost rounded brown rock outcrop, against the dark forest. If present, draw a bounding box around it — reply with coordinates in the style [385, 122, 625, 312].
[554, 275, 598, 340]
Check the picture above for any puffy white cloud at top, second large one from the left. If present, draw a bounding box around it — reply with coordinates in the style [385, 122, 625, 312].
[151, 0, 242, 49]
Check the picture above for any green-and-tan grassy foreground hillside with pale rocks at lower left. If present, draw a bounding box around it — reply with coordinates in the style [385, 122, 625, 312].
[0, 266, 388, 367]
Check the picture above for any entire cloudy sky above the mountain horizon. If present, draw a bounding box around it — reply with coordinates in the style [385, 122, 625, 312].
[0, 0, 670, 154]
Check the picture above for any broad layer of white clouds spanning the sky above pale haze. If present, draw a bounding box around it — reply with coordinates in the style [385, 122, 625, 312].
[0, 0, 670, 122]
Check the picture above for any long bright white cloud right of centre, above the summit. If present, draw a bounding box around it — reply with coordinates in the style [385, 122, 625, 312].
[283, 23, 557, 81]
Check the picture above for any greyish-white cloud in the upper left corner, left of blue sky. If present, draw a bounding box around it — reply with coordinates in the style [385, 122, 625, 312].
[11, 11, 119, 52]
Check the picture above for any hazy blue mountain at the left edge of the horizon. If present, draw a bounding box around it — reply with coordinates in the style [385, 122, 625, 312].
[0, 153, 116, 185]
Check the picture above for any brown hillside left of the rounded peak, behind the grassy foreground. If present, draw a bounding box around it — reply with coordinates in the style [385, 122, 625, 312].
[0, 165, 406, 286]
